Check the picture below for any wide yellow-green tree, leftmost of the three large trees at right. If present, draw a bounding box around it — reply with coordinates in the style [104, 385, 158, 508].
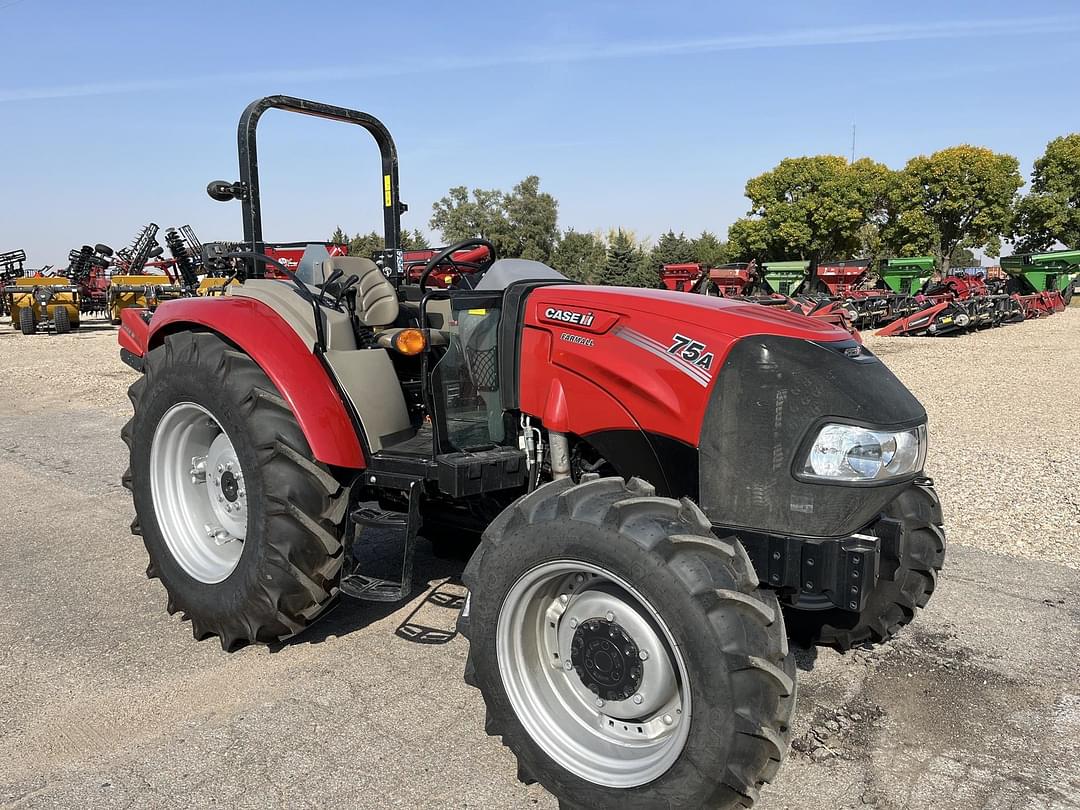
[728, 154, 892, 285]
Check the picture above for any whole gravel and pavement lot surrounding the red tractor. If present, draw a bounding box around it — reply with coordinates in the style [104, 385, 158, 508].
[0, 308, 1080, 810]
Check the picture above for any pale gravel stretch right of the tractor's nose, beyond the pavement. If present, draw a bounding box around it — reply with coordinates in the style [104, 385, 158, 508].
[866, 306, 1080, 568]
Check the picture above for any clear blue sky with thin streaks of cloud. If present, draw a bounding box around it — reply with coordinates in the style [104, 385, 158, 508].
[0, 0, 1080, 266]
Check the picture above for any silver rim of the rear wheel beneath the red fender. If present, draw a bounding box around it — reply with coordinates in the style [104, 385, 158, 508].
[150, 402, 247, 584]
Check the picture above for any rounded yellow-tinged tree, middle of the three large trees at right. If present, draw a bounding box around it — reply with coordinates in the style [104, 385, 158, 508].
[887, 145, 1024, 273]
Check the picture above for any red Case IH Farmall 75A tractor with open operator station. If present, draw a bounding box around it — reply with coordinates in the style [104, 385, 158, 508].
[120, 96, 945, 808]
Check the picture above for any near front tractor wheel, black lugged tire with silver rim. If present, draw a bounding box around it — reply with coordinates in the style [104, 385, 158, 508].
[459, 476, 795, 810]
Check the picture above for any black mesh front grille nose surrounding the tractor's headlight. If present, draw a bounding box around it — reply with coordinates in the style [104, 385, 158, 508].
[699, 335, 926, 537]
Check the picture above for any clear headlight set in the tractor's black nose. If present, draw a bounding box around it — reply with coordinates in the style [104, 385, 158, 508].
[800, 424, 927, 481]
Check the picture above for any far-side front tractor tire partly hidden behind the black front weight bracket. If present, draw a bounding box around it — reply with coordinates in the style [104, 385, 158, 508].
[784, 480, 945, 650]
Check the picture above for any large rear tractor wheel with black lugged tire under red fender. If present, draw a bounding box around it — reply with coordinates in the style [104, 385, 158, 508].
[121, 332, 349, 651]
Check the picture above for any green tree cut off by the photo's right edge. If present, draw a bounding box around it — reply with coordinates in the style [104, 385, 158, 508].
[1010, 132, 1080, 253]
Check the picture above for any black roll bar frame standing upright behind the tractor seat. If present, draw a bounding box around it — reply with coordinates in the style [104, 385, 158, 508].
[223, 95, 407, 285]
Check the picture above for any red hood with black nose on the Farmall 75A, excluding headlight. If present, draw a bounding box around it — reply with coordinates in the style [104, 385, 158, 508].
[518, 284, 926, 537]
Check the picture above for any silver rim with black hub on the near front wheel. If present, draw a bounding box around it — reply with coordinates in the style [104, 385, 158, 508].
[496, 559, 690, 788]
